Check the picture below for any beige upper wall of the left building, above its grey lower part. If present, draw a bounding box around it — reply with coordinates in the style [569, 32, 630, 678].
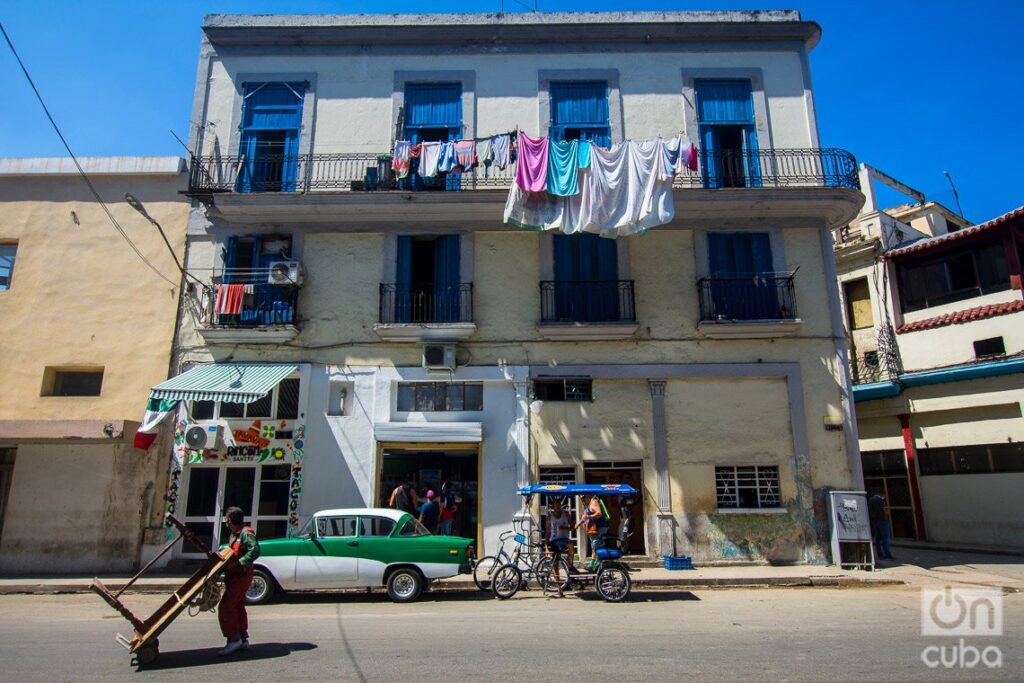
[0, 175, 188, 420]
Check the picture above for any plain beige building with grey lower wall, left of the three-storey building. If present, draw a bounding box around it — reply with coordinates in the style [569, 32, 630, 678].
[0, 157, 188, 573]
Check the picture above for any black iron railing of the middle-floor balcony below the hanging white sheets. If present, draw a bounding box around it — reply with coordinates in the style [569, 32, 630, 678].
[541, 280, 637, 323]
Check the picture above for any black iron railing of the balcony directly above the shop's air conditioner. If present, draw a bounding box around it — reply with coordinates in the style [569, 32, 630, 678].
[380, 283, 473, 324]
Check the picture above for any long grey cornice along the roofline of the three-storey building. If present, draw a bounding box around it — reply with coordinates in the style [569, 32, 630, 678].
[203, 10, 821, 49]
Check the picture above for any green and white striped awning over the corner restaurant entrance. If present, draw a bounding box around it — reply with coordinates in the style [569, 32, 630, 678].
[150, 362, 298, 403]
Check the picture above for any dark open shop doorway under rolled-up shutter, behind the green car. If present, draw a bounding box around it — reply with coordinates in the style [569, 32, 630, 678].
[377, 443, 480, 548]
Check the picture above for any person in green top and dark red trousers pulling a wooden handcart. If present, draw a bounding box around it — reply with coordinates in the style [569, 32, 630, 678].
[217, 508, 259, 656]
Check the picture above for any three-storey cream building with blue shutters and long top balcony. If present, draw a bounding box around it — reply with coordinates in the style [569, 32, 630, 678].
[154, 11, 863, 562]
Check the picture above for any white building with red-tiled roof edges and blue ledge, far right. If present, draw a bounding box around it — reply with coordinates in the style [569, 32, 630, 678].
[836, 165, 1024, 547]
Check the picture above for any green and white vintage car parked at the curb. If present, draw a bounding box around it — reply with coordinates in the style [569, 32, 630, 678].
[246, 508, 473, 604]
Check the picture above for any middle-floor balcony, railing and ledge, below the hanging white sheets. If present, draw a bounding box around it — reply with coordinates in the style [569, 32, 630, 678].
[538, 280, 638, 341]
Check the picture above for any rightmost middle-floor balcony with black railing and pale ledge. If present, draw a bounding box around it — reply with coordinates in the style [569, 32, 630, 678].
[697, 272, 801, 339]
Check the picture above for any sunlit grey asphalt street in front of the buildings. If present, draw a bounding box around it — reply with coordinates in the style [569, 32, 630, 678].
[0, 587, 1024, 682]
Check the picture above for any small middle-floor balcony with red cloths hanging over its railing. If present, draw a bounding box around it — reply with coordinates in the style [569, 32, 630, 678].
[199, 268, 301, 344]
